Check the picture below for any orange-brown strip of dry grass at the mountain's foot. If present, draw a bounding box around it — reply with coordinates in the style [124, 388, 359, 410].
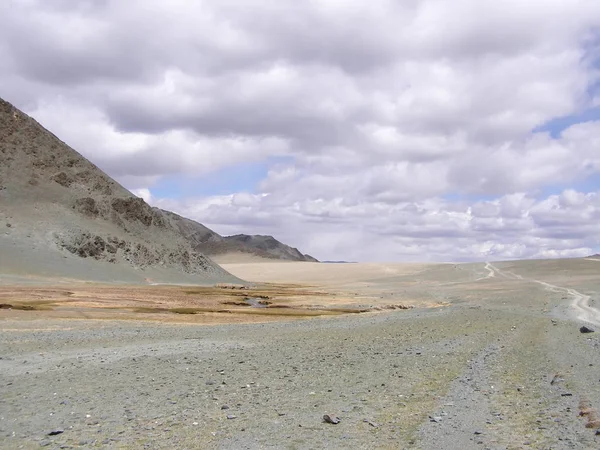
[0, 283, 414, 323]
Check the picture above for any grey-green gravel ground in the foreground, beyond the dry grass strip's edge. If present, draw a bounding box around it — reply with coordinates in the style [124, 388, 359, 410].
[0, 262, 600, 449]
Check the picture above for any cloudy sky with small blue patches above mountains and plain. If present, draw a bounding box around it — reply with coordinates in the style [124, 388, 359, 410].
[0, 0, 600, 262]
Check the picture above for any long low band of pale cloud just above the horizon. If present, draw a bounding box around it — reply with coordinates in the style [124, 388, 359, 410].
[157, 190, 600, 261]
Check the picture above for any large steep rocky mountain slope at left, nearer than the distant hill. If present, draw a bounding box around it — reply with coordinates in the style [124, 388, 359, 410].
[0, 99, 298, 283]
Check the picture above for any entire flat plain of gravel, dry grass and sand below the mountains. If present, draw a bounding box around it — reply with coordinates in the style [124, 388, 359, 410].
[0, 257, 600, 449]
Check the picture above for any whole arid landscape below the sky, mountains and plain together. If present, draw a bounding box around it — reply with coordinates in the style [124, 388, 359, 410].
[0, 96, 600, 449]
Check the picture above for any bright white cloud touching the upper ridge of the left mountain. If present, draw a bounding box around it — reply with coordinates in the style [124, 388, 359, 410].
[28, 101, 288, 181]
